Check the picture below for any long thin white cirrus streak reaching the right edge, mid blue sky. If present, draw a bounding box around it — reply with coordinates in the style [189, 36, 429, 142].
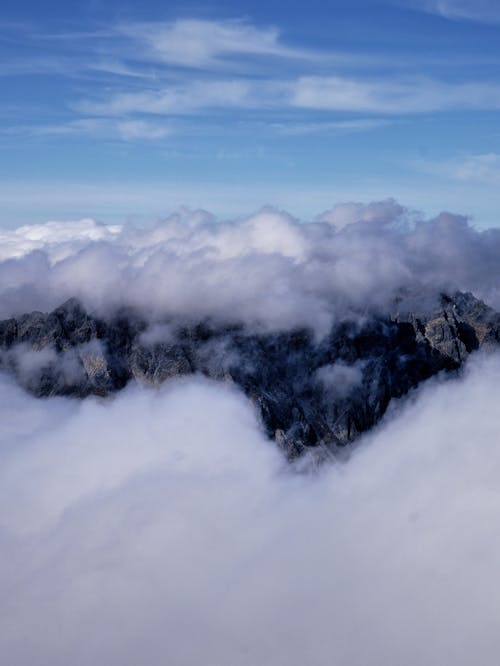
[74, 76, 500, 118]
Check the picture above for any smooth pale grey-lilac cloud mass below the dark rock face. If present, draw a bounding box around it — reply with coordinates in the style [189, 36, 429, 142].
[0, 356, 500, 666]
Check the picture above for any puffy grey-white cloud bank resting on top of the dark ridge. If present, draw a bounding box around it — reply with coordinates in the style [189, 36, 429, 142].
[0, 200, 500, 333]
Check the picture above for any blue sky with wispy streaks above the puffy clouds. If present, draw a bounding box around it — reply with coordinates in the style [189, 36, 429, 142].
[0, 0, 500, 226]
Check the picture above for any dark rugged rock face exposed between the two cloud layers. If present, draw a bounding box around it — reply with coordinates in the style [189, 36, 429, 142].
[0, 293, 500, 458]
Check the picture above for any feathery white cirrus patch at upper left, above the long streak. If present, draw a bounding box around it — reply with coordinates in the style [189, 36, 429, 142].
[0, 18, 312, 77]
